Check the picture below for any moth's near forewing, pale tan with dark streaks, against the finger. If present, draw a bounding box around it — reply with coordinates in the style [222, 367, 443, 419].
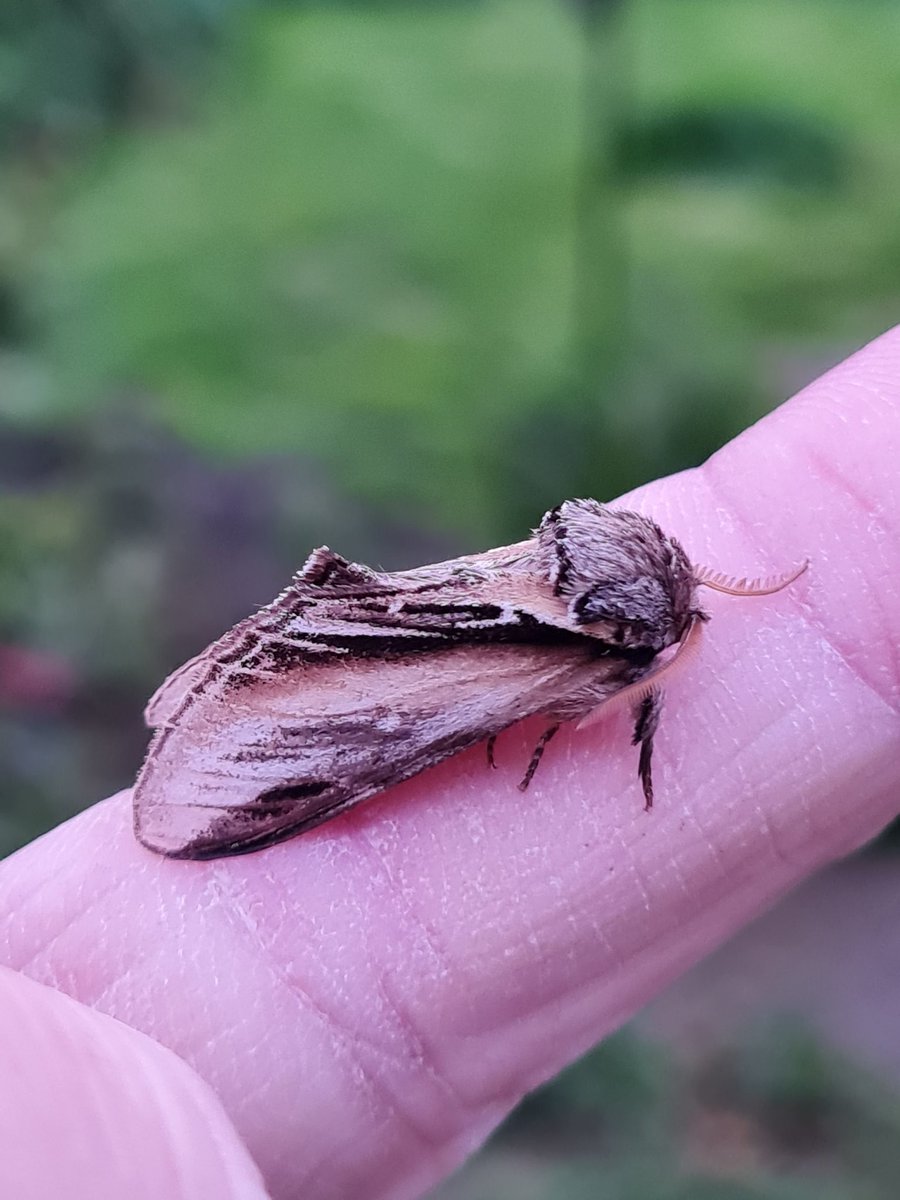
[134, 638, 607, 858]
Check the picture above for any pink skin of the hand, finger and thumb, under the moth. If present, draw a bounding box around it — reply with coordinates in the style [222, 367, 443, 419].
[0, 331, 900, 1200]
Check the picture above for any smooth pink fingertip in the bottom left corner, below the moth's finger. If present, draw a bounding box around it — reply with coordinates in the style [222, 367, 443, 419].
[0, 970, 268, 1200]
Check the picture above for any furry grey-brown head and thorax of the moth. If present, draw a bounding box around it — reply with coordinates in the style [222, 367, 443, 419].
[538, 500, 703, 652]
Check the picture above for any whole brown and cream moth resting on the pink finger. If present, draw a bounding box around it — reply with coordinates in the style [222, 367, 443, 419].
[134, 499, 806, 858]
